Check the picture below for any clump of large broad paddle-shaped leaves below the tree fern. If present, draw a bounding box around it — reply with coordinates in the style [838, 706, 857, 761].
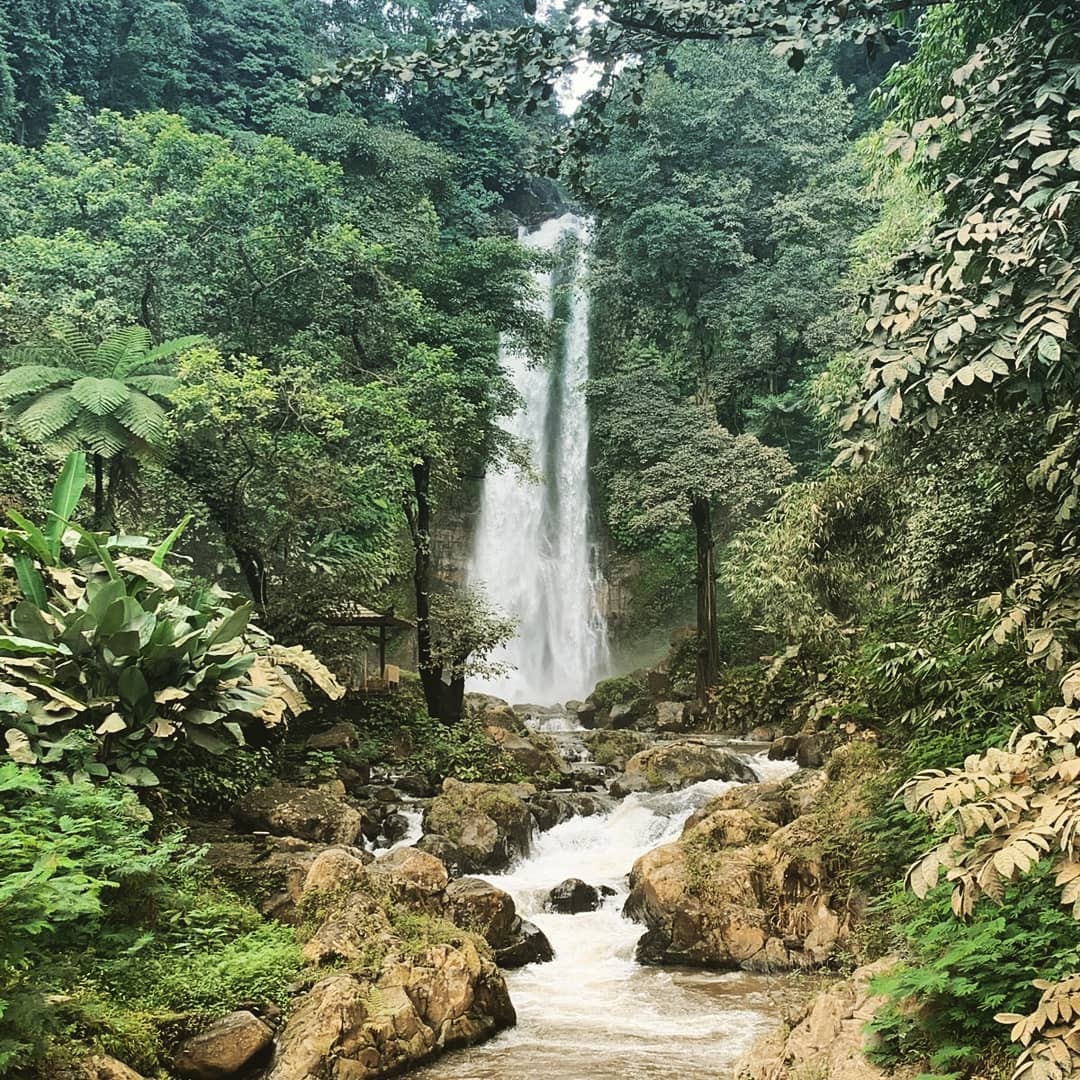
[0, 453, 343, 786]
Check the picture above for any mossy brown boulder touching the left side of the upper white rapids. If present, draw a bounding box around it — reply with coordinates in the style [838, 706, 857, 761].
[423, 779, 536, 873]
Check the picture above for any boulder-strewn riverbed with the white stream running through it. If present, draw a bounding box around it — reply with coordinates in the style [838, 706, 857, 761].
[79, 700, 898, 1080]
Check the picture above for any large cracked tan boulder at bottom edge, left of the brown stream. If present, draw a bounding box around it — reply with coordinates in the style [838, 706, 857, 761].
[267, 940, 515, 1080]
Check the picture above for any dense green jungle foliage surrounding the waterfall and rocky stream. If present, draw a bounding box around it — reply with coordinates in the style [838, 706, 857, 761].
[0, 0, 1080, 1080]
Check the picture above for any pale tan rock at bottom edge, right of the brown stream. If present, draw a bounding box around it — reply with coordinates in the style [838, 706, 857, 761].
[734, 957, 920, 1080]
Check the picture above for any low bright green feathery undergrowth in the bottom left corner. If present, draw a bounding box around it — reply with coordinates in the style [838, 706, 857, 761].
[0, 764, 302, 1076]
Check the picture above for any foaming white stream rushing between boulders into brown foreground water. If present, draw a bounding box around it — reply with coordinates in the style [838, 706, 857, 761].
[408, 743, 794, 1080]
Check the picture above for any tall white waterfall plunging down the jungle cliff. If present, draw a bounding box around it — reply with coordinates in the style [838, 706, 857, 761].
[469, 214, 608, 703]
